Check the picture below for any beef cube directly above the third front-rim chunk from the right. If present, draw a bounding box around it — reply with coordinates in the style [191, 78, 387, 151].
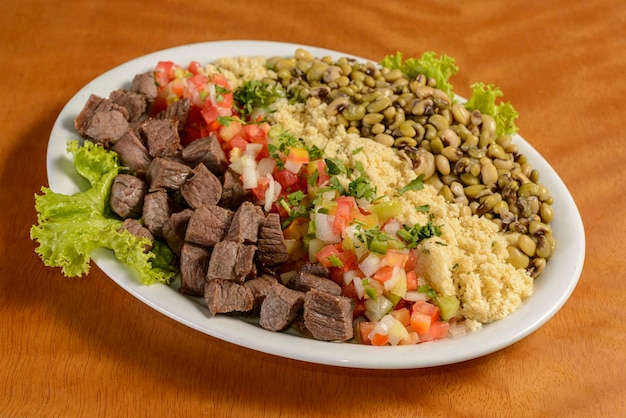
[207, 241, 257, 283]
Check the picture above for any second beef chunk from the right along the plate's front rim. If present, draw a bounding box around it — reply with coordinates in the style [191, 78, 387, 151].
[259, 285, 304, 331]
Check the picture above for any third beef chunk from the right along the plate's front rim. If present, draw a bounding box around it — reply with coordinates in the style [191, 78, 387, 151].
[204, 279, 254, 315]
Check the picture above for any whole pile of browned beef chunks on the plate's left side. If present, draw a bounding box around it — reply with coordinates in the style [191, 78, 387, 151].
[75, 73, 354, 341]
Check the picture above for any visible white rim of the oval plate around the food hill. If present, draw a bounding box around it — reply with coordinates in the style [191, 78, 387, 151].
[46, 40, 586, 369]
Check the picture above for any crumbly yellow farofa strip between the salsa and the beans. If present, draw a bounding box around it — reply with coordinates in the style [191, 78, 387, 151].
[213, 57, 533, 329]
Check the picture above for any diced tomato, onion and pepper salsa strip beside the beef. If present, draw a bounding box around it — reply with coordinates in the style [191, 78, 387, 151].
[151, 62, 464, 346]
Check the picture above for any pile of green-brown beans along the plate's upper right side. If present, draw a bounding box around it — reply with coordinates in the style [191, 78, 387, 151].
[265, 49, 556, 278]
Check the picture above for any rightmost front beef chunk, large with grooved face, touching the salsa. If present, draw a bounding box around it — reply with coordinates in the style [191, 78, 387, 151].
[304, 289, 354, 341]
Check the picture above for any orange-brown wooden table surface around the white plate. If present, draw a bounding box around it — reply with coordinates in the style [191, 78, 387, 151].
[0, 0, 626, 418]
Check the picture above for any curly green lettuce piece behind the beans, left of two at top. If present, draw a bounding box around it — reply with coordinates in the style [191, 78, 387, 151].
[380, 51, 459, 98]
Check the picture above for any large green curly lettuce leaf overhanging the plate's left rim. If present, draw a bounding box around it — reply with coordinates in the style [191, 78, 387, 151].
[30, 141, 177, 285]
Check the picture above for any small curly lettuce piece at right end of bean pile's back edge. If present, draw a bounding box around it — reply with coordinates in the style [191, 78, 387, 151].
[465, 83, 519, 135]
